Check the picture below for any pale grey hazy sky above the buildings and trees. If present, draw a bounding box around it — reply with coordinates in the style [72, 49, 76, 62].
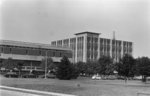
[0, 0, 150, 58]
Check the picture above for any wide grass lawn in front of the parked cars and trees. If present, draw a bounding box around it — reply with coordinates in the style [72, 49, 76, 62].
[0, 77, 150, 96]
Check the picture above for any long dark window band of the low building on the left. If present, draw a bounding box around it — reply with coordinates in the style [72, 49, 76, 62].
[0, 46, 72, 58]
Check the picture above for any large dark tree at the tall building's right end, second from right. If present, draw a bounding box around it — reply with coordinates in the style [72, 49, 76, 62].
[116, 54, 135, 77]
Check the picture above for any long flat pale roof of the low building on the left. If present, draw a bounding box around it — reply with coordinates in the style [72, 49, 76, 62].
[0, 40, 71, 50]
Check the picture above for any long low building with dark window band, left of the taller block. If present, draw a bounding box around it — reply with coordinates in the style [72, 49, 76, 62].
[0, 40, 72, 70]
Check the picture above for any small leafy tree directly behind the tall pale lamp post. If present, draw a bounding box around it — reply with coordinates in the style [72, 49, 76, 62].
[41, 58, 56, 72]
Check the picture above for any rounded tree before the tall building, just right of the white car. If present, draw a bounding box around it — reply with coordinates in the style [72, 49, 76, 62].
[97, 56, 114, 75]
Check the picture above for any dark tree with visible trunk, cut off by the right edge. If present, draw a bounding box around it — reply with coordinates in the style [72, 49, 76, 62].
[136, 57, 150, 82]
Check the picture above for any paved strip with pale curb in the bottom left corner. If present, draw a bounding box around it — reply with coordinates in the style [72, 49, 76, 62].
[0, 86, 75, 96]
